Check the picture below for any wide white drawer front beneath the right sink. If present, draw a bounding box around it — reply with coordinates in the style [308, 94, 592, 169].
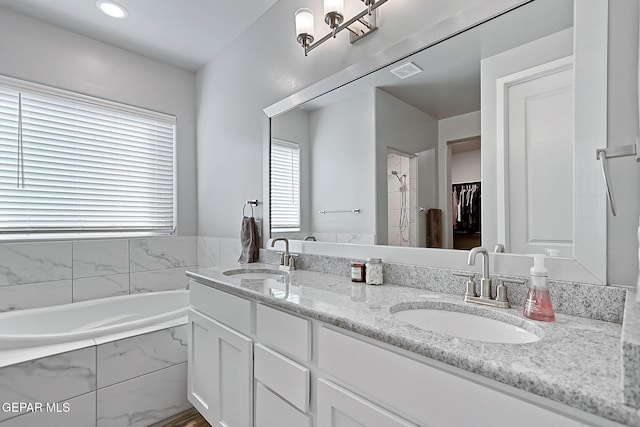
[318, 327, 584, 427]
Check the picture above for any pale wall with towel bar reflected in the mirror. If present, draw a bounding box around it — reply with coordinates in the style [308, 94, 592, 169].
[309, 90, 376, 235]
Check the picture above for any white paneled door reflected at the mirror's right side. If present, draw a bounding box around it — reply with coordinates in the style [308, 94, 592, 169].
[498, 58, 574, 257]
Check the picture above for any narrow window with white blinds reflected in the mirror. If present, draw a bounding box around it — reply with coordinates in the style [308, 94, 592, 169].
[271, 139, 300, 231]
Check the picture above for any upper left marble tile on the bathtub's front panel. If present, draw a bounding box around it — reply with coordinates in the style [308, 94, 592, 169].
[0, 347, 96, 421]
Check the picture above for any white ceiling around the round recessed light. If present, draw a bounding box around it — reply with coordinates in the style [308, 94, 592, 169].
[0, 0, 277, 71]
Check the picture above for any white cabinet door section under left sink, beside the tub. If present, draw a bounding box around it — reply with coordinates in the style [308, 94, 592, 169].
[188, 310, 253, 427]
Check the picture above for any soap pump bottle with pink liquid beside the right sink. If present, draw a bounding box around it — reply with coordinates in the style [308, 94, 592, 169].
[522, 254, 556, 322]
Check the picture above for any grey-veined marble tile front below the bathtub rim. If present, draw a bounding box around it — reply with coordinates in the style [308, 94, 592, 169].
[0, 325, 190, 427]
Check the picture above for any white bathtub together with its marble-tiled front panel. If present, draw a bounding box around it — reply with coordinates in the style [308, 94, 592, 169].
[0, 290, 191, 427]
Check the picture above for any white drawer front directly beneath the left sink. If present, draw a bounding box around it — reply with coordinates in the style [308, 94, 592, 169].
[189, 281, 251, 334]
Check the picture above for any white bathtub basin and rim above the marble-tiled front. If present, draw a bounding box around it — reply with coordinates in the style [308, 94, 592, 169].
[0, 290, 189, 351]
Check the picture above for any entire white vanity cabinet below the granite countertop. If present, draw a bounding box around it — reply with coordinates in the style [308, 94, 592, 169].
[188, 283, 618, 427]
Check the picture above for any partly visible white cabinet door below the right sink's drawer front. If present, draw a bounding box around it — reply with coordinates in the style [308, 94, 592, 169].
[317, 378, 415, 427]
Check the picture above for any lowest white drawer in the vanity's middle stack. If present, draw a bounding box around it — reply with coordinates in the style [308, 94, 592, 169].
[256, 383, 311, 427]
